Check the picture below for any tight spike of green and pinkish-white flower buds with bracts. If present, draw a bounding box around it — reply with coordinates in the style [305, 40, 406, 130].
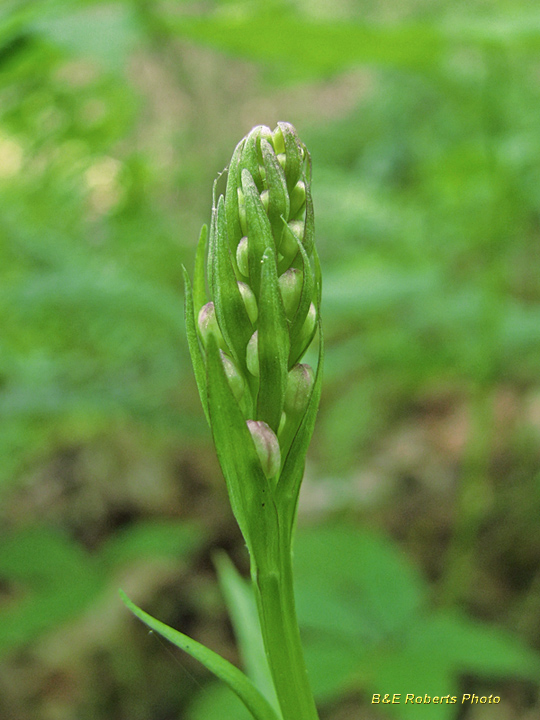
[189, 122, 321, 478]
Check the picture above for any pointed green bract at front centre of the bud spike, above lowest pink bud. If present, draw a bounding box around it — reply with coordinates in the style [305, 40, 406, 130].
[257, 248, 289, 433]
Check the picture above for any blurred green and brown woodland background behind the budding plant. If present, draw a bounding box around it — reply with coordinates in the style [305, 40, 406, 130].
[0, 0, 540, 720]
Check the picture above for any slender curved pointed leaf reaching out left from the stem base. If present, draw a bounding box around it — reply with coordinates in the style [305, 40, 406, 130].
[120, 590, 279, 720]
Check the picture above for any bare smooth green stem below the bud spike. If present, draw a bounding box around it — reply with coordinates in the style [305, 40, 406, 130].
[253, 533, 319, 720]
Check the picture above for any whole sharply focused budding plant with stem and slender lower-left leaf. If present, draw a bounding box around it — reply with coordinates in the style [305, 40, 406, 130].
[124, 123, 323, 720]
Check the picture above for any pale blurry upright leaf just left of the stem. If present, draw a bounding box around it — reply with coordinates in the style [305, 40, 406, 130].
[214, 552, 280, 714]
